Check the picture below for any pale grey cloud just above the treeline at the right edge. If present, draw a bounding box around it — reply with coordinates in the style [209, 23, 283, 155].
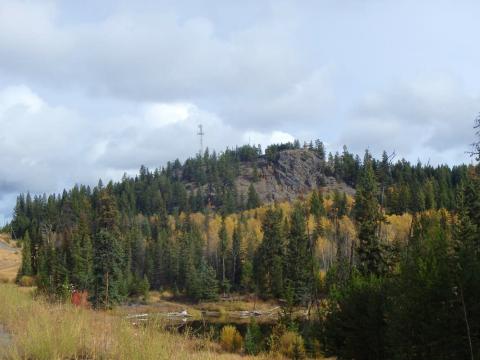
[341, 74, 480, 162]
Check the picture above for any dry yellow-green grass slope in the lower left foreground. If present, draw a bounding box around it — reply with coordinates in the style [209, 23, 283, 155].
[0, 284, 268, 360]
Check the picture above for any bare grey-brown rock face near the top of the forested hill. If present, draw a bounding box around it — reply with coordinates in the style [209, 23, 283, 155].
[236, 149, 355, 203]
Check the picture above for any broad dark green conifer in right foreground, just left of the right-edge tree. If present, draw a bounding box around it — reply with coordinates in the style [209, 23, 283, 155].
[385, 214, 470, 359]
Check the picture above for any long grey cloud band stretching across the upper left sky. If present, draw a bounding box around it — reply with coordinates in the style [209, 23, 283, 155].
[0, 0, 334, 130]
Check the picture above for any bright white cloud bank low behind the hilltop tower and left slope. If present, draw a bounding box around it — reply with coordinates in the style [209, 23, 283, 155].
[0, 85, 300, 220]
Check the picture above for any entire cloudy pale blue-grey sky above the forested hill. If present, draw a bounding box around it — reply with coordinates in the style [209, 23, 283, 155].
[0, 0, 480, 225]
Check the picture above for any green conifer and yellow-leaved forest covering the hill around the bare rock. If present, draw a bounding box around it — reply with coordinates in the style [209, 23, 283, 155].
[9, 121, 480, 359]
